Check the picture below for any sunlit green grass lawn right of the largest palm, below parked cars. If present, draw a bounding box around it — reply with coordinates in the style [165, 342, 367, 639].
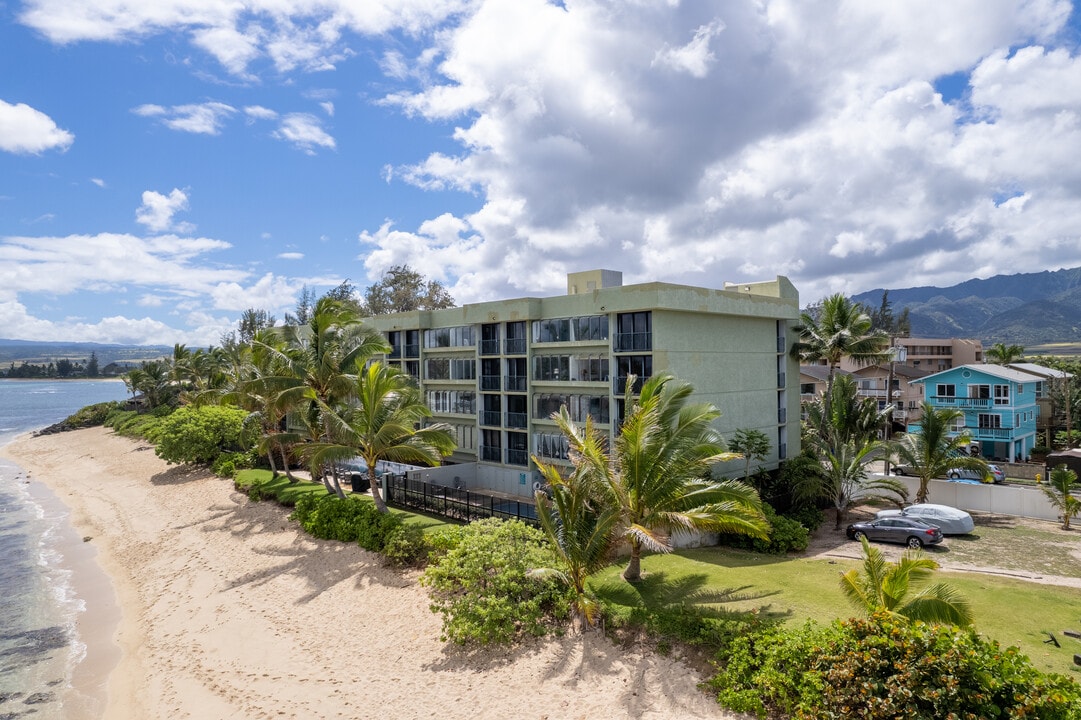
[591, 547, 1081, 680]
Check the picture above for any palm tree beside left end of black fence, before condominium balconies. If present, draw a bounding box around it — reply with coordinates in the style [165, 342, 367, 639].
[305, 361, 456, 512]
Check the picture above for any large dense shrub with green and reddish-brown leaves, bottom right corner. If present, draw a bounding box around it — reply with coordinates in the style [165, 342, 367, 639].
[710, 614, 1081, 720]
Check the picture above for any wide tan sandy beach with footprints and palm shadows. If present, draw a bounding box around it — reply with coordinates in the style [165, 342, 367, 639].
[3, 428, 735, 720]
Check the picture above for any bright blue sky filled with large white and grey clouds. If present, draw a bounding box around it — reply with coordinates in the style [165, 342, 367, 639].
[0, 0, 1081, 346]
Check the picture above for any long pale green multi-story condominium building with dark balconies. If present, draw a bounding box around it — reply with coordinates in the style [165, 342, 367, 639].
[365, 270, 800, 496]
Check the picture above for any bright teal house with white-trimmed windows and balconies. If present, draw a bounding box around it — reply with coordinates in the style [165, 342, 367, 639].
[909, 364, 1044, 462]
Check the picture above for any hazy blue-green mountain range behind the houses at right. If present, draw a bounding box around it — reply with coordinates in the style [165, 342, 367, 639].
[852, 267, 1081, 347]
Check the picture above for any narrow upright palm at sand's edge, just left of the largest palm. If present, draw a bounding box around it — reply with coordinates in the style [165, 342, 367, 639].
[531, 406, 619, 625]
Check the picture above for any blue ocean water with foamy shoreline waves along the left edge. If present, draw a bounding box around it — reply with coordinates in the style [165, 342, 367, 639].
[0, 379, 128, 720]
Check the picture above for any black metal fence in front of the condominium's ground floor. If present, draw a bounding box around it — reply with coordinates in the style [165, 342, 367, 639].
[384, 475, 538, 525]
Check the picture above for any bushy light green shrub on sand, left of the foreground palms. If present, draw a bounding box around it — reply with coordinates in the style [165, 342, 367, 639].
[421, 518, 570, 644]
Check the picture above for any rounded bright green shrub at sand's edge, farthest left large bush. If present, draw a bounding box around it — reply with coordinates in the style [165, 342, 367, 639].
[155, 405, 250, 464]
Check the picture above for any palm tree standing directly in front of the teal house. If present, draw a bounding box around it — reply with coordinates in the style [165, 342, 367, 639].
[894, 402, 989, 503]
